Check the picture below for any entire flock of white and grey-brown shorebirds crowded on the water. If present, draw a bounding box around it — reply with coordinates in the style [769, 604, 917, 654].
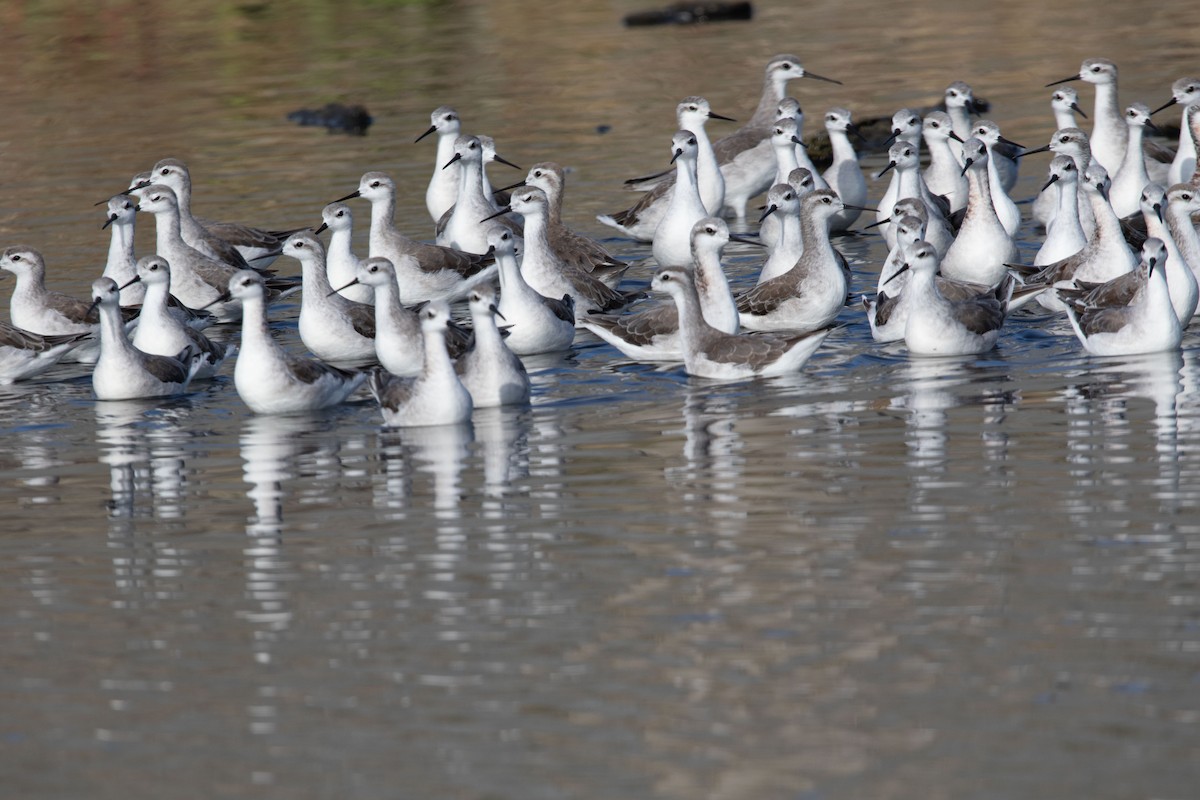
[0, 55, 1200, 426]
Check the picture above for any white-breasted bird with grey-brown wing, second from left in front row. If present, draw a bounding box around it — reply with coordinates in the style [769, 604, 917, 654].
[220, 270, 366, 414]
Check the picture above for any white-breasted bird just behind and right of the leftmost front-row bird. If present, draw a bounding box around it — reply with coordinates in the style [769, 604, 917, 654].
[129, 255, 238, 380]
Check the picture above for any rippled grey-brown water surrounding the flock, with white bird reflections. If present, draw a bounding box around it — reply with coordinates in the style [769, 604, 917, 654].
[0, 1, 1200, 800]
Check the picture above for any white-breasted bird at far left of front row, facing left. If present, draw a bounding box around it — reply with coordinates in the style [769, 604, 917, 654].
[91, 278, 202, 401]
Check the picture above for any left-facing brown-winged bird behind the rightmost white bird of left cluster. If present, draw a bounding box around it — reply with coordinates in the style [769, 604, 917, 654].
[500, 186, 637, 323]
